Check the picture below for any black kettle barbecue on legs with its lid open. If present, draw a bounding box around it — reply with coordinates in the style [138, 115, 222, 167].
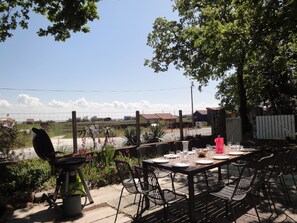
[32, 128, 94, 207]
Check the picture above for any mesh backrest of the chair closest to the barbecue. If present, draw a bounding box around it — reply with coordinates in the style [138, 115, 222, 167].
[114, 159, 139, 194]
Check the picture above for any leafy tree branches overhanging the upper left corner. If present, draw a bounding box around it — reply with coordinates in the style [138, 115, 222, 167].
[0, 0, 100, 42]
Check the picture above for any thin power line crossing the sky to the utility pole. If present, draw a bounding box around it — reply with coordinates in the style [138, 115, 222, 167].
[0, 87, 188, 93]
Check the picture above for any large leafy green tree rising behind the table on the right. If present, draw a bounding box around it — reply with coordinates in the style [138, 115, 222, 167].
[145, 0, 297, 136]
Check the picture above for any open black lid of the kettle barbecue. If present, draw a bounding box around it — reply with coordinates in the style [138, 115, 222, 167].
[32, 128, 56, 162]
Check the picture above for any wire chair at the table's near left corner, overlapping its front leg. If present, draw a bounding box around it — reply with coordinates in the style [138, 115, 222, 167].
[134, 166, 187, 220]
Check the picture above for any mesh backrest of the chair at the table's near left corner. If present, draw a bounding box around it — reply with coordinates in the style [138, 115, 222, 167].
[134, 166, 166, 205]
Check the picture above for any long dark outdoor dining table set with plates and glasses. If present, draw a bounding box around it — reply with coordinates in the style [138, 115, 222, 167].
[142, 148, 258, 222]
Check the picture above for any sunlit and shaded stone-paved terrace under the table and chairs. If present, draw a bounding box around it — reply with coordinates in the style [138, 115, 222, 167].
[4, 161, 297, 223]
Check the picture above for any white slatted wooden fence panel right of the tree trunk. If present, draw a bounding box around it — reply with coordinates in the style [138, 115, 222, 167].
[256, 115, 296, 140]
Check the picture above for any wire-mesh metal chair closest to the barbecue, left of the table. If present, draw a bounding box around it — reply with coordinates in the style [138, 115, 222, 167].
[114, 159, 142, 222]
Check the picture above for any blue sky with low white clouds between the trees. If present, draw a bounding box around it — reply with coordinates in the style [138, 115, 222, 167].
[0, 0, 218, 122]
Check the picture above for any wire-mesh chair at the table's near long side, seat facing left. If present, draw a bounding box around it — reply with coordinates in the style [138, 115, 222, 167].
[206, 153, 271, 222]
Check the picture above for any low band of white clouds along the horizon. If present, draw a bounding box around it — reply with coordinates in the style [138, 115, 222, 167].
[0, 94, 217, 121]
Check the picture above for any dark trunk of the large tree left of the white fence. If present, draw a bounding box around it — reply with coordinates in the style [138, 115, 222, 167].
[237, 61, 252, 137]
